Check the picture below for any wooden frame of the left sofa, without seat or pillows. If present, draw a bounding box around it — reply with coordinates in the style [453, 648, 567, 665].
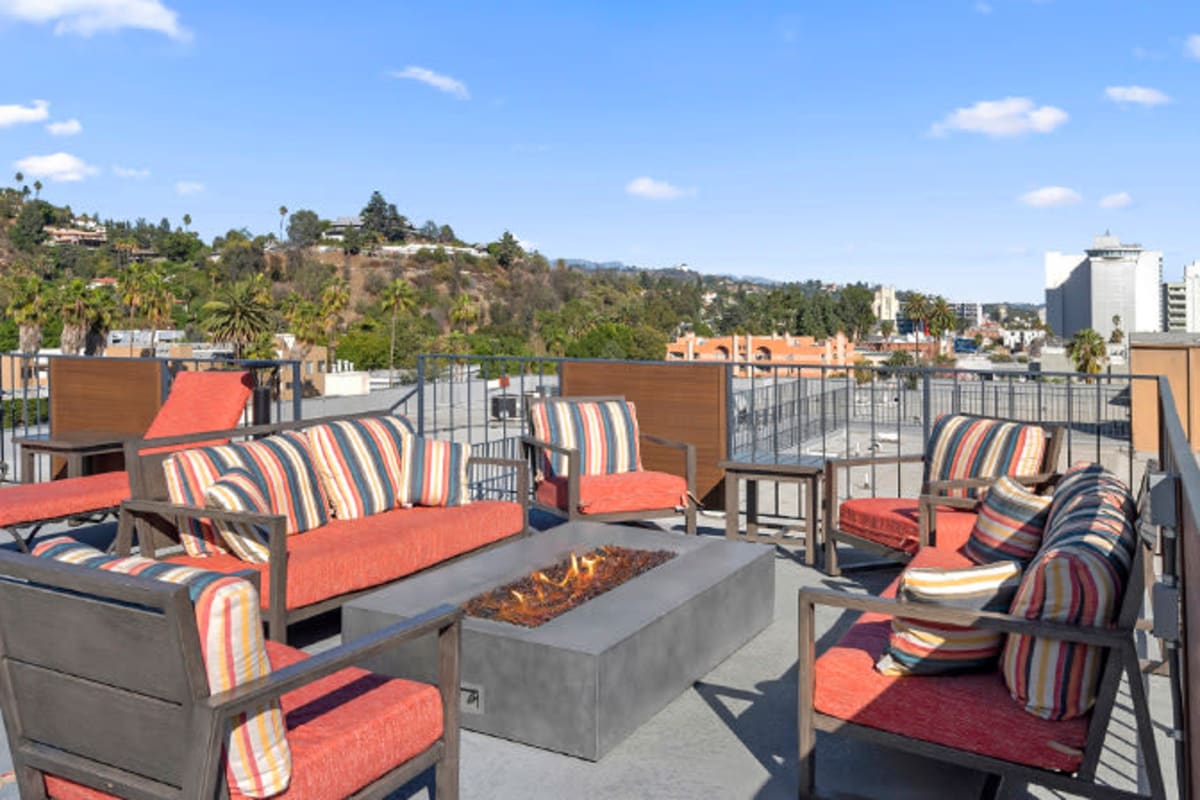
[115, 414, 529, 642]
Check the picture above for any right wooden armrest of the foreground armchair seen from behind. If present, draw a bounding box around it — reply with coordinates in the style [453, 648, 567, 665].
[204, 604, 462, 718]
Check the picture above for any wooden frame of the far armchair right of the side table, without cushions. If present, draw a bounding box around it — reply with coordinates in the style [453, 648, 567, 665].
[823, 420, 1066, 576]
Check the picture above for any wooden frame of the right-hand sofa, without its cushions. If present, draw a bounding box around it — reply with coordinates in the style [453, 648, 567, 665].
[798, 522, 1166, 800]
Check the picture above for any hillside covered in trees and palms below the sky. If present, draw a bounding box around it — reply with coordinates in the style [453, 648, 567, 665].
[0, 174, 964, 369]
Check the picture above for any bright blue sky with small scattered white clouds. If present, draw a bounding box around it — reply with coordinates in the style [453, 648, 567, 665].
[0, 0, 1200, 301]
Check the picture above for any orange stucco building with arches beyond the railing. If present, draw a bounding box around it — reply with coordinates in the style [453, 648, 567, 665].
[667, 333, 854, 378]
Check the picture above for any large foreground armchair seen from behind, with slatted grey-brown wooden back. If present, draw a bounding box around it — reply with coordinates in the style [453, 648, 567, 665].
[0, 537, 461, 800]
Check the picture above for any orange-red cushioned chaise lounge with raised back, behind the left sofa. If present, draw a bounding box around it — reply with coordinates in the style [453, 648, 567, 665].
[0, 369, 251, 552]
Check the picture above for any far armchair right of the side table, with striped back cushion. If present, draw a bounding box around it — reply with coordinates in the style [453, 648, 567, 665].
[824, 415, 1062, 576]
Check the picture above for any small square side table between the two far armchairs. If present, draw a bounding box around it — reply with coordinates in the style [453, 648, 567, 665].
[719, 452, 826, 566]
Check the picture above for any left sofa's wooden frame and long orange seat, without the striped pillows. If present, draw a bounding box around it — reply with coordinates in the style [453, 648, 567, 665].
[116, 413, 529, 642]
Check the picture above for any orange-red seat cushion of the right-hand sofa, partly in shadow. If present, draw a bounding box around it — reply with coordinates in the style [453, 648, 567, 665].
[814, 547, 1087, 772]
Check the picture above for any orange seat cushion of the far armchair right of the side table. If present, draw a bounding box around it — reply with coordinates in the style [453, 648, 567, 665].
[838, 498, 976, 555]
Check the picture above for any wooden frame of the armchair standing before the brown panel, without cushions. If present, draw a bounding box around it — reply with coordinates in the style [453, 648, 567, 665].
[521, 395, 696, 536]
